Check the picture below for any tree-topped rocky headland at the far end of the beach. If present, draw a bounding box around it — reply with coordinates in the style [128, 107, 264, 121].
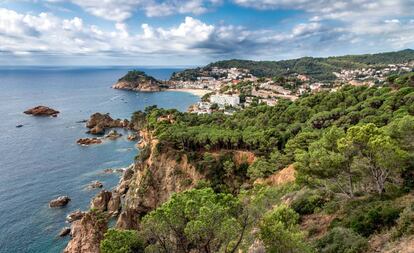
[112, 70, 161, 92]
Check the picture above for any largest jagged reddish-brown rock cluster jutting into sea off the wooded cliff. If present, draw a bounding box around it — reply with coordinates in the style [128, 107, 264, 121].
[86, 113, 129, 135]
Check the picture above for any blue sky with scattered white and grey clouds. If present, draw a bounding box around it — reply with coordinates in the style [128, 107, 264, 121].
[0, 0, 414, 66]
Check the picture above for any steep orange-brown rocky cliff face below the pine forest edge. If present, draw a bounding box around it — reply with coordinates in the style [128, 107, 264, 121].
[117, 132, 204, 229]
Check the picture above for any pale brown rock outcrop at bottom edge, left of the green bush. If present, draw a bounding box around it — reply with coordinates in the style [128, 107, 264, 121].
[64, 211, 108, 253]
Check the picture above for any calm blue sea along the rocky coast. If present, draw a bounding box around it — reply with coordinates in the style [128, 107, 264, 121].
[0, 67, 199, 253]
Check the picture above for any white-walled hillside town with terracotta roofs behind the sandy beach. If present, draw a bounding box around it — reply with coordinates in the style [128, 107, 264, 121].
[166, 61, 414, 114]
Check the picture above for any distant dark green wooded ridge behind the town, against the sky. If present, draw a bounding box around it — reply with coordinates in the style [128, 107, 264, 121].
[173, 49, 414, 81]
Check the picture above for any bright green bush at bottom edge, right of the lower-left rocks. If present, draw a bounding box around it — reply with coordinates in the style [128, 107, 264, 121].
[100, 229, 143, 253]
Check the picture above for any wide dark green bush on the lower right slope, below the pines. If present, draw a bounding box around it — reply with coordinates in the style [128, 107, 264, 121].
[340, 201, 401, 237]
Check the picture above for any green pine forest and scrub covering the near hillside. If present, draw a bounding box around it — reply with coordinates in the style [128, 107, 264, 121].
[102, 74, 414, 253]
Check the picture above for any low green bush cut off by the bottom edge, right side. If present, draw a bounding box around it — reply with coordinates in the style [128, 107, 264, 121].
[316, 227, 368, 253]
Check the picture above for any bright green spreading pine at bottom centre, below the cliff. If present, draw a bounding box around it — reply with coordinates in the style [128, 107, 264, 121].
[142, 188, 242, 253]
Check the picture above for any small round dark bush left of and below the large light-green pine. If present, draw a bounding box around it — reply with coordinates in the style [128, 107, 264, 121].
[291, 191, 326, 215]
